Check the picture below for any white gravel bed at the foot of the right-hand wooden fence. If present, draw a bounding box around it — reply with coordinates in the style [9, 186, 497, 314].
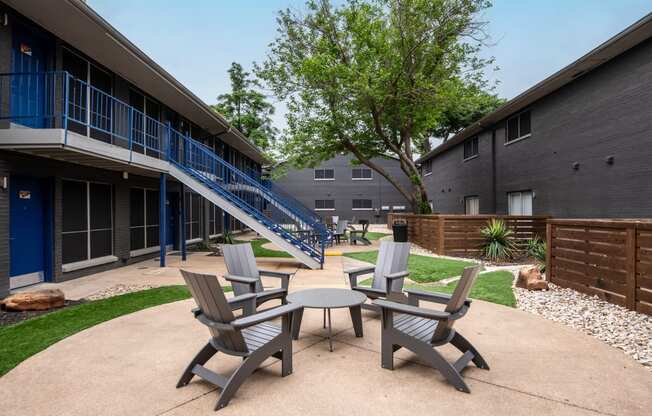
[514, 284, 652, 371]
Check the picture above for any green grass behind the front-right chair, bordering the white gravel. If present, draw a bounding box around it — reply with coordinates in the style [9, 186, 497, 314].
[409, 271, 516, 308]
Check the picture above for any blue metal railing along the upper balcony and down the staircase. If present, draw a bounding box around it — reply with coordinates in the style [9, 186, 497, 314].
[0, 71, 331, 265]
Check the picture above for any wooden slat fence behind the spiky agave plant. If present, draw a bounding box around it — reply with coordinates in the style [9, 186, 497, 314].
[387, 214, 548, 256]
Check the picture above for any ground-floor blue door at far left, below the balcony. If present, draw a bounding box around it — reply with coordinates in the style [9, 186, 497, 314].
[9, 176, 48, 289]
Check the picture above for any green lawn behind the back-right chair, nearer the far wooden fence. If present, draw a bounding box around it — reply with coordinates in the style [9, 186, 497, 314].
[344, 251, 474, 283]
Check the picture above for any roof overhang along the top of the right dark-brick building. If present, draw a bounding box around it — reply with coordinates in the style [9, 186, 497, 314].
[417, 13, 652, 163]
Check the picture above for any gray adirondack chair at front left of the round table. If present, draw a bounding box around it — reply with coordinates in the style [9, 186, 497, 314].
[177, 270, 301, 410]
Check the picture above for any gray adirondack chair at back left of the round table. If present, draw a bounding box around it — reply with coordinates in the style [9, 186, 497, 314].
[222, 243, 292, 306]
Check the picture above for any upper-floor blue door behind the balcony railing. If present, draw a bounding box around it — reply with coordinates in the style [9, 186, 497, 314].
[10, 25, 52, 128]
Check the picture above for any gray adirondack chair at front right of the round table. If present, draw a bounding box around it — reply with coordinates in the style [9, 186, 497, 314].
[374, 266, 489, 393]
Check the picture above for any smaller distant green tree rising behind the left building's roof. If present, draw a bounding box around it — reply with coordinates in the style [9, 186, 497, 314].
[212, 62, 278, 150]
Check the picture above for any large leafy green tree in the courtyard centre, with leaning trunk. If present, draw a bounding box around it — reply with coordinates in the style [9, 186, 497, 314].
[256, 0, 490, 212]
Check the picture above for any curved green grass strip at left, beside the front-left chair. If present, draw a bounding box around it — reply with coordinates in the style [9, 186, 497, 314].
[0, 286, 222, 376]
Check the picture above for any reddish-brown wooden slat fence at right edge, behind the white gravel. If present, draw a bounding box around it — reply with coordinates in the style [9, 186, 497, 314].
[546, 219, 652, 315]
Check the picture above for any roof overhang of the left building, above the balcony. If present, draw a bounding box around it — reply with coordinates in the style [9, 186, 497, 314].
[3, 0, 268, 163]
